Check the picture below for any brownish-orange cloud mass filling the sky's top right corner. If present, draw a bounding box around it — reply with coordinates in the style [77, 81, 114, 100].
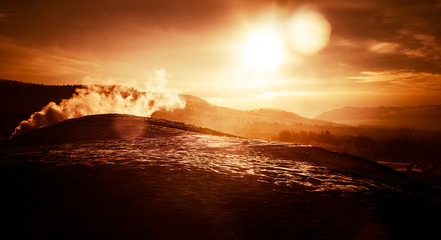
[315, 0, 441, 73]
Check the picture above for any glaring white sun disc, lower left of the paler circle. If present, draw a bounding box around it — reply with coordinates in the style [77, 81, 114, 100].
[241, 28, 286, 72]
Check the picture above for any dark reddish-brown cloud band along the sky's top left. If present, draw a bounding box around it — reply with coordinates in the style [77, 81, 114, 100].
[0, 0, 235, 44]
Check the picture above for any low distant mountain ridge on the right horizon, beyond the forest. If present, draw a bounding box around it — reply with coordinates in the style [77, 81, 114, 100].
[315, 105, 441, 130]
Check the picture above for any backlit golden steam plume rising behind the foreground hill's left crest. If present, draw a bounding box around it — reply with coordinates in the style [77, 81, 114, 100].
[10, 69, 185, 139]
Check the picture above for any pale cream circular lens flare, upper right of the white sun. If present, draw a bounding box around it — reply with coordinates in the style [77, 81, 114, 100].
[286, 9, 331, 55]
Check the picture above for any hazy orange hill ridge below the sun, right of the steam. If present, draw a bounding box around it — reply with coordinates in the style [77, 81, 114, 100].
[152, 95, 341, 139]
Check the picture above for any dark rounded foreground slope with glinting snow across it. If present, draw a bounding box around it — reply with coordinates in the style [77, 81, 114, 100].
[0, 114, 441, 239]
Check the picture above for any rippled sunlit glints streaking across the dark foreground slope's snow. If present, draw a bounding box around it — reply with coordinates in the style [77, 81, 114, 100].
[6, 133, 388, 192]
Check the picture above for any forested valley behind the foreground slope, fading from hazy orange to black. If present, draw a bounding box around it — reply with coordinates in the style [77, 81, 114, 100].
[207, 121, 441, 172]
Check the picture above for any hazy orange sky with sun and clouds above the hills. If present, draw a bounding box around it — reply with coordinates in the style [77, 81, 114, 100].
[0, 0, 441, 116]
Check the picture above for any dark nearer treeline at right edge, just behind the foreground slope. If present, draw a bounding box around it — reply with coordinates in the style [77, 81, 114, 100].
[274, 128, 441, 172]
